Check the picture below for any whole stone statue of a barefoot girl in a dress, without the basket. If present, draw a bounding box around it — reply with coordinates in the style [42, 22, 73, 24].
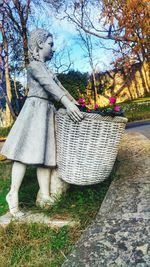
[1, 28, 83, 218]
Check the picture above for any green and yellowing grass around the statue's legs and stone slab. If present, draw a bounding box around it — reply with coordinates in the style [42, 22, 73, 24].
[0, 162, 114, 267]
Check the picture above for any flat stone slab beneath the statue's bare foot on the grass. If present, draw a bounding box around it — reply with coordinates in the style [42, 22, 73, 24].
[0, 211, 79, 228]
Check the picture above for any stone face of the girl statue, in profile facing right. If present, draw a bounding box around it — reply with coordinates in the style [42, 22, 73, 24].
[42, 36, 55, 61]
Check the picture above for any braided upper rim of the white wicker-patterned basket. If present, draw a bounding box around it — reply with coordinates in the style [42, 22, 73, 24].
[56, 108, 128, 124]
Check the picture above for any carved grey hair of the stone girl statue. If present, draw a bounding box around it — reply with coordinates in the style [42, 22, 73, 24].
[28, 28, 53, 60]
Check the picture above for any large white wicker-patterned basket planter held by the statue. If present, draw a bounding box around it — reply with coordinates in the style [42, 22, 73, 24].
[56, 109, 127, 185]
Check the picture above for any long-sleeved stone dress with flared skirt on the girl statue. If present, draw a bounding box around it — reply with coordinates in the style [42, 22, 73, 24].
[1, 60, 74, 167]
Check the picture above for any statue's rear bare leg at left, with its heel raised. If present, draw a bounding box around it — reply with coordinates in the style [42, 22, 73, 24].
[6, 161, 26, 216]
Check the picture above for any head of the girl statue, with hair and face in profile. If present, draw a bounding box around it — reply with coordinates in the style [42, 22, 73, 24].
[28, 28, 54, 61]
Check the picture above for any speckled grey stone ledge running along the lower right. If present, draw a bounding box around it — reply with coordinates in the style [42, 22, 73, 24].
[62, 133, 150, 267]
